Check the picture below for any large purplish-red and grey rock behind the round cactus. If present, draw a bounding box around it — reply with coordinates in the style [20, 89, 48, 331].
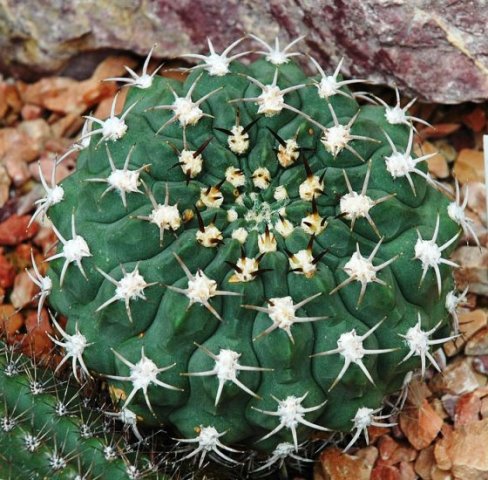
[0, 0, 488, 103]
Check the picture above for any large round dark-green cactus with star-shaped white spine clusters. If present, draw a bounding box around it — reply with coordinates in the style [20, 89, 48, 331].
[36, 36, 466, 467]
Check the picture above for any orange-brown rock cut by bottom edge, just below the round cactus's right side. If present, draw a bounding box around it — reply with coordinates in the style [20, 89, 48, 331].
[319, 446, 378, 480]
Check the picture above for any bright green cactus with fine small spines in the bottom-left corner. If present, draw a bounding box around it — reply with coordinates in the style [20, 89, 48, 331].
[0, 342, 160, 480]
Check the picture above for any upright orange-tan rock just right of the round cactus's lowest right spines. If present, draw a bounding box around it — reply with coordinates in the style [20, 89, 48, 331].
[399, 399, 442, 450]
